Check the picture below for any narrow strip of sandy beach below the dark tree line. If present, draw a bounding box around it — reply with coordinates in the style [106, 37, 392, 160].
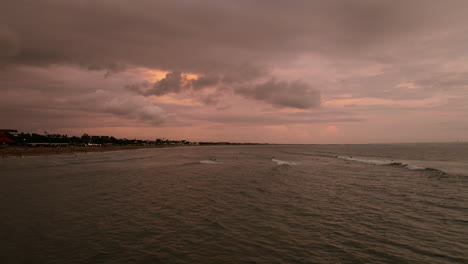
[0, 145, 178, 158]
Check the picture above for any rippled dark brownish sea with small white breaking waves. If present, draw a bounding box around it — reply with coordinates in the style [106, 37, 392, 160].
[0, 144, 468, 263]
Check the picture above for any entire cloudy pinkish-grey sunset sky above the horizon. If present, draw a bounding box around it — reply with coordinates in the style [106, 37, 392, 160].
[0, 0, 468, 144]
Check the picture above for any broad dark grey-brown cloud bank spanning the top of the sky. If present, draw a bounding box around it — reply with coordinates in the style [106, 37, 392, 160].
[0, 0, 467, 96]
